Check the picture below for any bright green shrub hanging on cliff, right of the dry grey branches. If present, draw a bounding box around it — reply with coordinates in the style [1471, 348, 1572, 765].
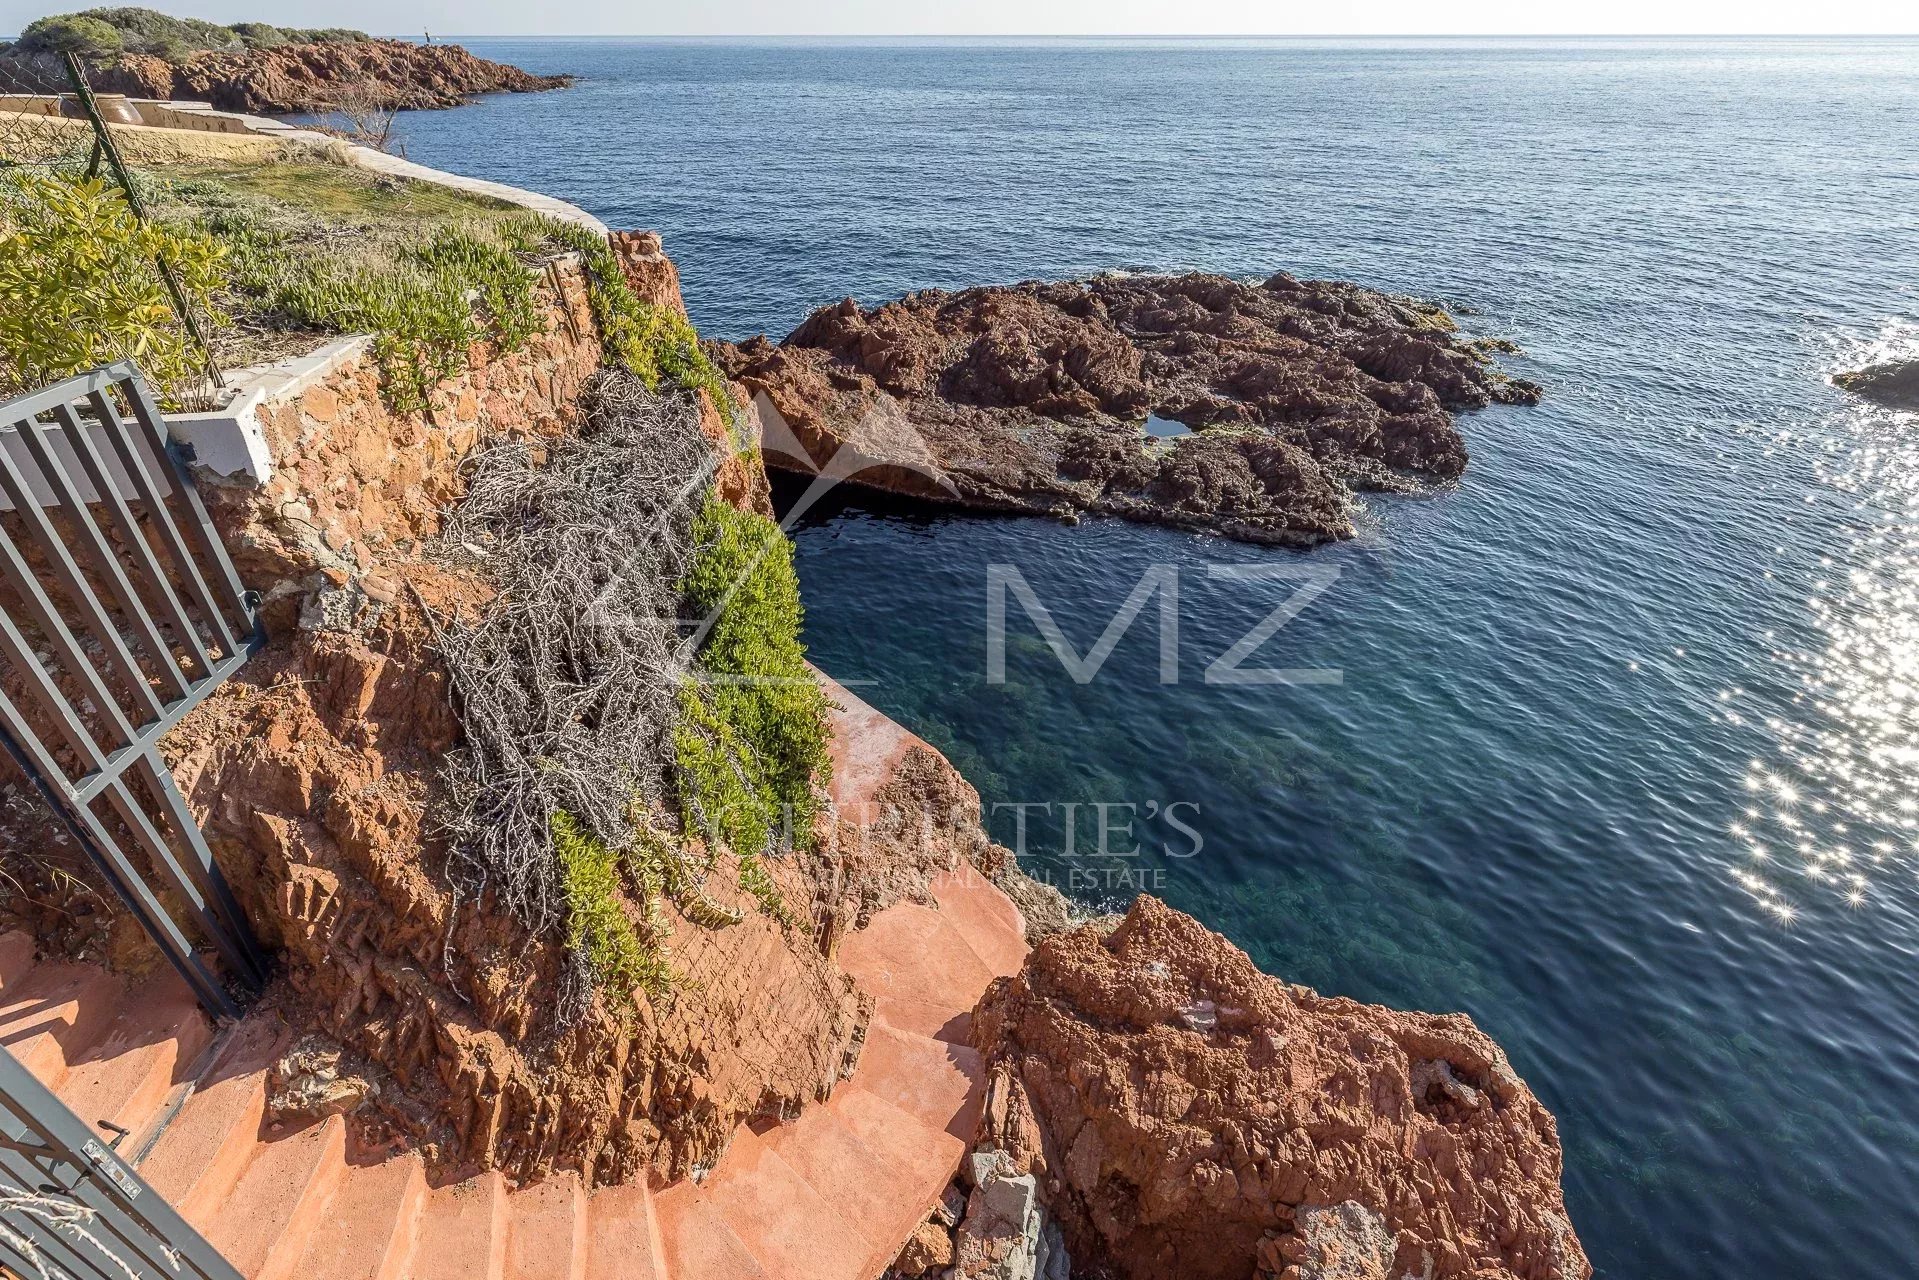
[674, 495, 833, 913]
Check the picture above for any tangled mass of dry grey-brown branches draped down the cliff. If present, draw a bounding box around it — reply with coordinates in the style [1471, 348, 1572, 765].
[424, 370, 716, 1021]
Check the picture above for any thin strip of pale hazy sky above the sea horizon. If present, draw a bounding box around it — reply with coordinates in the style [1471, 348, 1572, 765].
[0, 0, 1919, 36]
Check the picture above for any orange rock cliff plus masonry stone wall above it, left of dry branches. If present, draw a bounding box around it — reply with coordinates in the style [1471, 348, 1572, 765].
[149, 245, 867, 1182]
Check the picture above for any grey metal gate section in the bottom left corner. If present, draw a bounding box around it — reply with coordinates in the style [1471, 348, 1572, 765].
[0, 1050, 240, 1280]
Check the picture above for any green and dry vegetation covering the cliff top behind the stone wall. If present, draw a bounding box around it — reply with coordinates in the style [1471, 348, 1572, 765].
[0, 165, 566, 402]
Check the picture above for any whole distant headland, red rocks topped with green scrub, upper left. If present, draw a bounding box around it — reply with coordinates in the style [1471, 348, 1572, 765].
[0, 8, 570, 115]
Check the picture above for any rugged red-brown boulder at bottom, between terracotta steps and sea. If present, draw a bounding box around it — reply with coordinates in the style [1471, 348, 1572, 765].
[973, 898, 1591, 1280]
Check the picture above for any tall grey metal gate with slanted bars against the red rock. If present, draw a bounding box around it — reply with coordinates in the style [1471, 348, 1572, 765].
[0, 363, 265, 1017]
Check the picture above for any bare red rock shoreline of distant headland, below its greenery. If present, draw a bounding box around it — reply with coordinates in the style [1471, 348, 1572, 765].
[0, 40, 572, 115]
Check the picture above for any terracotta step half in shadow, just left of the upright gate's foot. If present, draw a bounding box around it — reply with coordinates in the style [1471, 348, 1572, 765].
[59, 971, 213, 1138]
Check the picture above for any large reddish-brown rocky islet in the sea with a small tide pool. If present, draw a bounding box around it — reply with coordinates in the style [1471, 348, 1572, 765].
[712, 273, 1541, 545]
